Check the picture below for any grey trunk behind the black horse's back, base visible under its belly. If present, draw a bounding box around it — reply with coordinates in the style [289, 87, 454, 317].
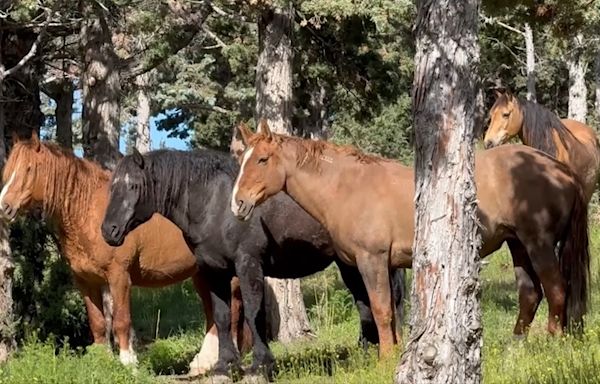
[256, 3, 310, 342]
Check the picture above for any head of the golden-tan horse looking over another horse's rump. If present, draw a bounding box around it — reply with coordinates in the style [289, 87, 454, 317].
[483, 90, 523, 148]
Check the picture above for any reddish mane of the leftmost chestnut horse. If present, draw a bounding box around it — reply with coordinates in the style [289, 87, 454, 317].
[4, 141, 109, 219]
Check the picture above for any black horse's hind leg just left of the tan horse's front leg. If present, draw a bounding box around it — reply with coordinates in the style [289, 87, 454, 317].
[336, 260, 379, 350]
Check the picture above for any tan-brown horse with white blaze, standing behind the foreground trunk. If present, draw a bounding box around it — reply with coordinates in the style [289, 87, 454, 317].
[231, 122, 589, 355]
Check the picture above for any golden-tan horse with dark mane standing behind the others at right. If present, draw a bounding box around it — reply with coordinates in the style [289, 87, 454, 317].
[484, 91, 600, 202]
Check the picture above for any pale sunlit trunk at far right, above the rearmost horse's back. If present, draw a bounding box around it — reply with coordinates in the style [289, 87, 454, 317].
[567, 33, 588, 123]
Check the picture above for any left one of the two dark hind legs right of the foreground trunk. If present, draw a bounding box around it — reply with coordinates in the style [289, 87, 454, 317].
[507, 240, 543, 336]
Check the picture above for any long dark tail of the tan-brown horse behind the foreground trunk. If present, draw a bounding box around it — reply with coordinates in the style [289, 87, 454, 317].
[559, 175, 590, 332]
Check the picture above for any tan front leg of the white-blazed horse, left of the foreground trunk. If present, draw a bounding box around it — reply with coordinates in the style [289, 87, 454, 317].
[356, 254, 396, 357]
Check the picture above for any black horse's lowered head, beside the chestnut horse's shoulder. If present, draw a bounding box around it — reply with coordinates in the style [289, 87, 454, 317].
[102, 149, 153, 246]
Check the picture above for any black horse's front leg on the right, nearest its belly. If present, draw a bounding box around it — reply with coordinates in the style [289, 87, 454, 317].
[235, 254, 275, 377]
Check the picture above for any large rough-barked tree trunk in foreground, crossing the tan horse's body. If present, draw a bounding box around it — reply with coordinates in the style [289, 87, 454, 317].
[396, 0, 482, 384]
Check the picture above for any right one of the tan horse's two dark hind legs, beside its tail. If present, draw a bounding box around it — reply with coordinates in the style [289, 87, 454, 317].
[527, 239, 566, 335]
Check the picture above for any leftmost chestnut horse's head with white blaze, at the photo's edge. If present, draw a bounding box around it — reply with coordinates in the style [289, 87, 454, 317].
[0, 131, 44, 220]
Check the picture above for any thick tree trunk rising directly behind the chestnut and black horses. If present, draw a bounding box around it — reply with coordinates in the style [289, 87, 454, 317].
[80, 0, 121, 169]
